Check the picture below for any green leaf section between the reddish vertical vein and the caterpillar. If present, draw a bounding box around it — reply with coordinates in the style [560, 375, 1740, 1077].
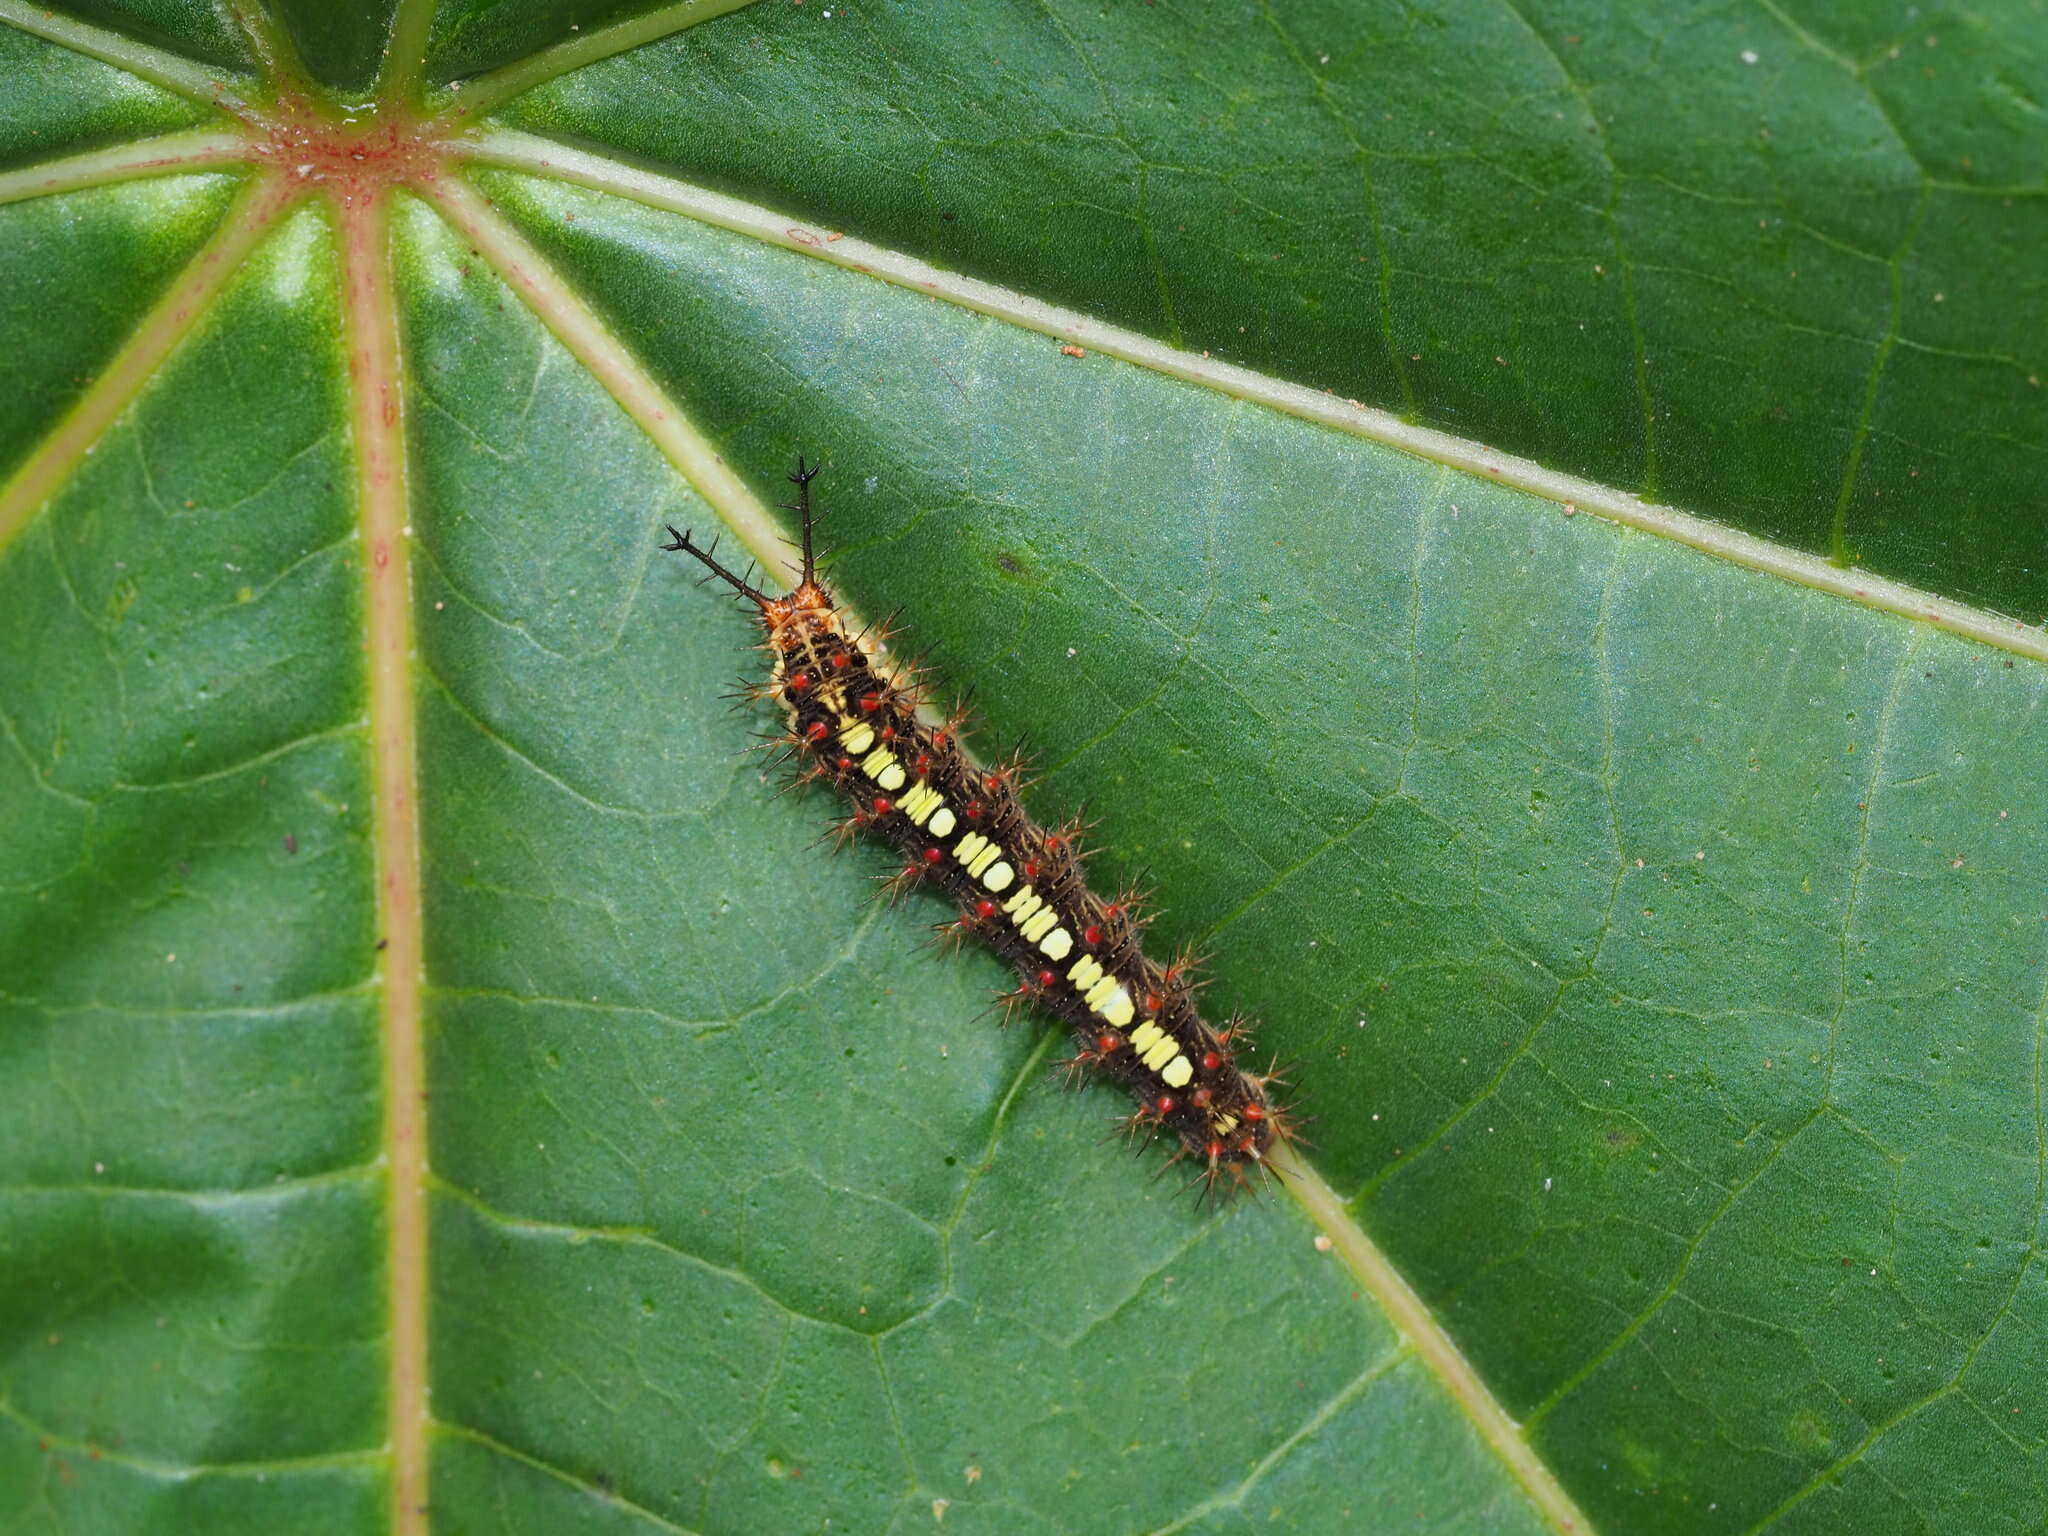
[406, 195, 1534, 1530]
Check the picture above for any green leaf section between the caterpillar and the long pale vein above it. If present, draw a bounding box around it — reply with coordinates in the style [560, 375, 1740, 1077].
[485, 174, 2048, 1530]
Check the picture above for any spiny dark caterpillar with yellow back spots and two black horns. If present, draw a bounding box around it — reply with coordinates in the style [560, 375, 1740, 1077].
[664, 459, 1290, 1188]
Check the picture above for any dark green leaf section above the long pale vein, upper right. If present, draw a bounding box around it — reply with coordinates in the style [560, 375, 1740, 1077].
[491, 0, 2048, 623]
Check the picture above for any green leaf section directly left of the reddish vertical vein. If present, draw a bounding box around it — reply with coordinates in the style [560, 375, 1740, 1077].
[0, 209, 385, 1532]
